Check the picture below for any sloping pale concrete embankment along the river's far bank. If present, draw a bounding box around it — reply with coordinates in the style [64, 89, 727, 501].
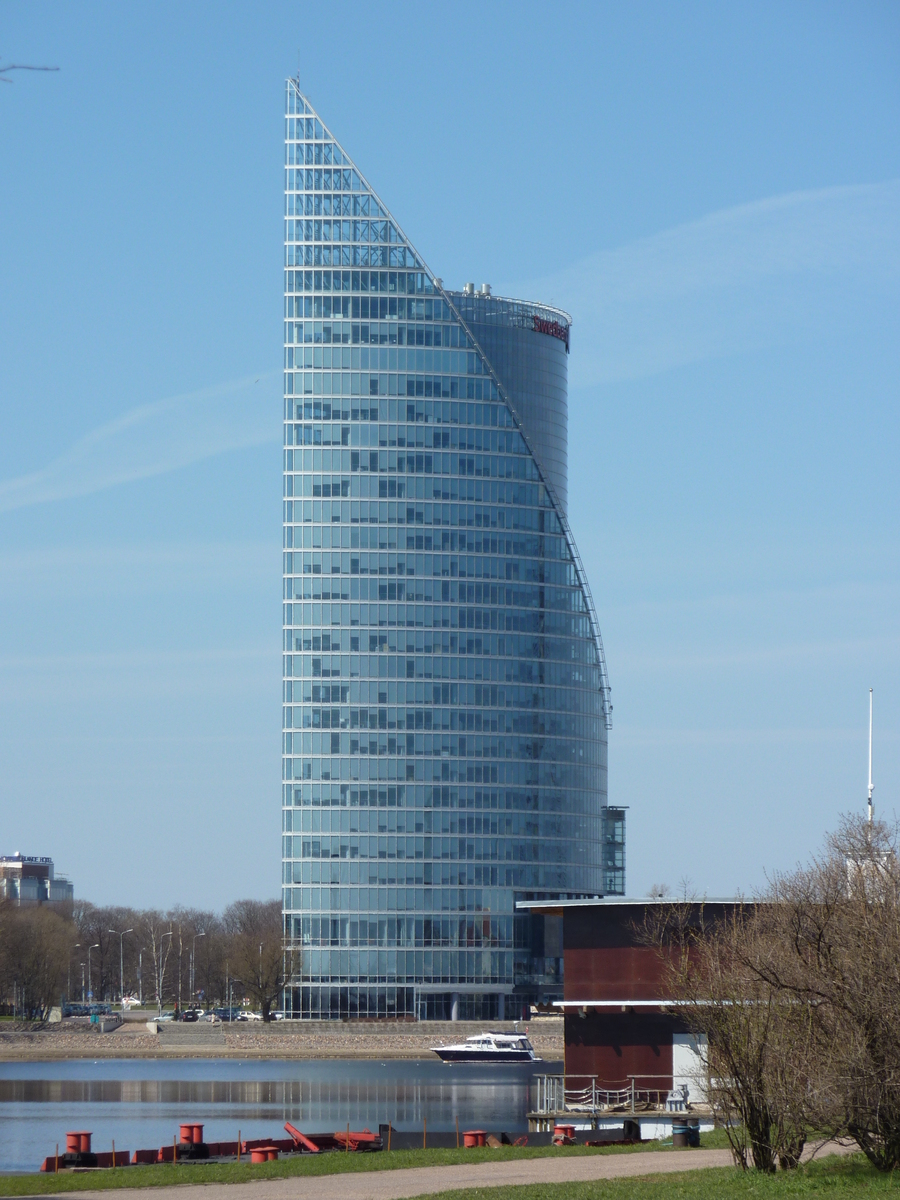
[0, 1014, 563, 1062]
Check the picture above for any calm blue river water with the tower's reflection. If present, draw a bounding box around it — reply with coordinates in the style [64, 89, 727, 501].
[0, 1058, 560, 1171]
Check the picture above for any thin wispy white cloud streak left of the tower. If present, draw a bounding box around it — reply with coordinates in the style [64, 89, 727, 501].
[0, 371, 281, 512]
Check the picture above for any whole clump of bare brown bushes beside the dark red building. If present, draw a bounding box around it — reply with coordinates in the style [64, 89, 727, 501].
[648, 818, 900, 1171]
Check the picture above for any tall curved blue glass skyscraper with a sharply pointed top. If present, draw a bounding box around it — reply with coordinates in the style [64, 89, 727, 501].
[283, 79, 624, 1019]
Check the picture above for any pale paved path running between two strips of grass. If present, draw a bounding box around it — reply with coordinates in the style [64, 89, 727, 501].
[68, 1150, 732, 1200]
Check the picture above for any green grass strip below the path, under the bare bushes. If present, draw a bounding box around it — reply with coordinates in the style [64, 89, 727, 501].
[416, 1154, 900, 1200]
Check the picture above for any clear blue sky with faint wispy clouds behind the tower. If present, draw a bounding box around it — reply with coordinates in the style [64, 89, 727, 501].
[0, 0, 900, 906]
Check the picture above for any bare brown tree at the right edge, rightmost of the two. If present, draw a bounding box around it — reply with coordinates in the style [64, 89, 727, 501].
[757, 817, 900, 1171]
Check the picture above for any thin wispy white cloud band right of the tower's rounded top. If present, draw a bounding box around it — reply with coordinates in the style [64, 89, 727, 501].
[508, 180, 900, 386]
